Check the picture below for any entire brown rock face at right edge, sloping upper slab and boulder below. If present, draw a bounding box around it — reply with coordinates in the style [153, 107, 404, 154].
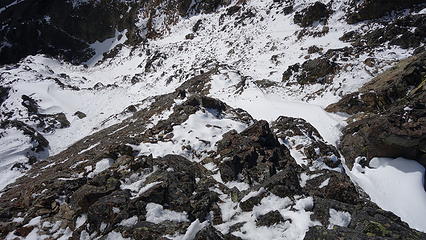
[327, 52, 426, 167]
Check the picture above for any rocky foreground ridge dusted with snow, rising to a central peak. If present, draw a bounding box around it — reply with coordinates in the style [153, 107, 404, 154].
[0, 71, 425, 239]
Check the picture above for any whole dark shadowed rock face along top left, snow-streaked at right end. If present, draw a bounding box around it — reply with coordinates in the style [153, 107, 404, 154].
[0, 0, 228, 64]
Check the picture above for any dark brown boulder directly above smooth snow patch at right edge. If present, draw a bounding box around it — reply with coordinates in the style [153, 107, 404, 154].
[340, 104, 426, 167]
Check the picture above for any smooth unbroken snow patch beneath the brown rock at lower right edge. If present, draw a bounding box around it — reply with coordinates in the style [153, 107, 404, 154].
[349, 158, 426, 232]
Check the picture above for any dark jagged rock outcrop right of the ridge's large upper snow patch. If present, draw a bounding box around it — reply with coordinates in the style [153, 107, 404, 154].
[217, 121, 297, 184]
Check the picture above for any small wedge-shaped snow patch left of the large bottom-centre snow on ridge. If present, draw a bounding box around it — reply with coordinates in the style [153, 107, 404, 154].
[146, 203, 188, 223]
